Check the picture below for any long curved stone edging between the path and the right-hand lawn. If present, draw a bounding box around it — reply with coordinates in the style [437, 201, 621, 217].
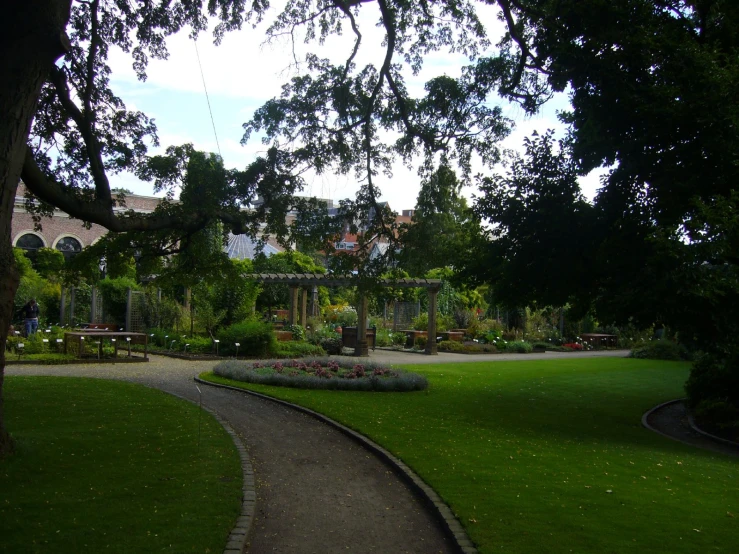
[194, 377, 478, 554]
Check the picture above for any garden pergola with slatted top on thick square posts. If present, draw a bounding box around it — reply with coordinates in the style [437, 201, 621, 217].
[244, 273, 441, 356]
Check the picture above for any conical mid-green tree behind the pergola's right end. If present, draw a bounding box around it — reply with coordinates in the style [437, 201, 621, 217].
[399, 165, 482, 276]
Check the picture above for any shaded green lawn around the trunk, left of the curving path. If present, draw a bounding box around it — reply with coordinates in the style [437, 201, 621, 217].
[0, 377, 242, 554]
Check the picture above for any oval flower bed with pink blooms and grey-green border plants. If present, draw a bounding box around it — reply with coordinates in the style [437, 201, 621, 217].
[213, 358, 428, 392]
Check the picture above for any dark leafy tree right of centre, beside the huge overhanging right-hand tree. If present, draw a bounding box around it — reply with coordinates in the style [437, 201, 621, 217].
[462, 131, 598, 312]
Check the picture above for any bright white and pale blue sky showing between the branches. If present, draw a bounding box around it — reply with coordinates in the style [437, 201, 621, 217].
[110, 3, 598, 212]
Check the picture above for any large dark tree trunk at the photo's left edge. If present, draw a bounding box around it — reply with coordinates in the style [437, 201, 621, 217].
[0, 0, 71, 457]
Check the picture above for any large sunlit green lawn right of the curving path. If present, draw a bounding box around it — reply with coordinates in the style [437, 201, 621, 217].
[202, 358, 739, 553]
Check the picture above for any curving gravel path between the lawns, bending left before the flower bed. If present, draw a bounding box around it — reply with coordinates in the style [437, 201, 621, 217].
[6, 356, 457, 554]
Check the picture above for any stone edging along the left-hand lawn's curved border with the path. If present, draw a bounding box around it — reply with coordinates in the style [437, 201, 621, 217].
[163, 379, 257, 554]
